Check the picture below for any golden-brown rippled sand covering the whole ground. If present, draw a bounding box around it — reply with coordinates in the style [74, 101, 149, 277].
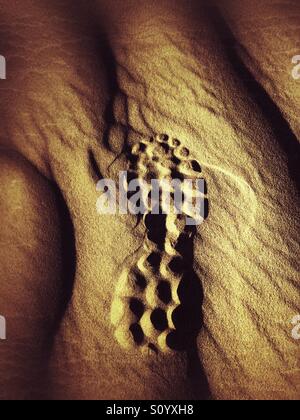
[0, 0, 300, 400]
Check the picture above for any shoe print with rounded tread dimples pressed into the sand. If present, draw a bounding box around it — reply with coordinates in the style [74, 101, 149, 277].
[111, 135, 209, 354]
